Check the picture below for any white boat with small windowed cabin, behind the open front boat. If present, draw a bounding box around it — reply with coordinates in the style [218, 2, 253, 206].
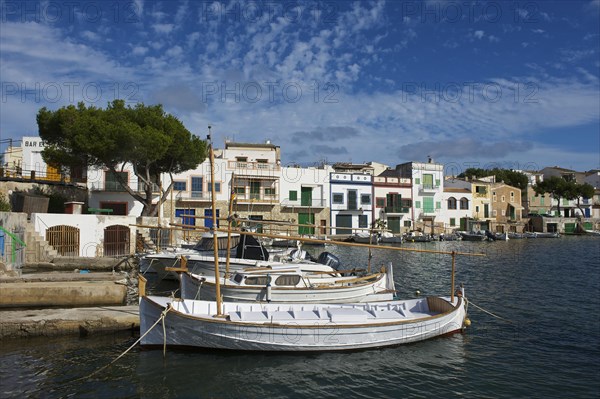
[180, 264, 395, 303]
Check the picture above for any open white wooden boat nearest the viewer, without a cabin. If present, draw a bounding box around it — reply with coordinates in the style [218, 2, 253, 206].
[140, 290, 466, 352]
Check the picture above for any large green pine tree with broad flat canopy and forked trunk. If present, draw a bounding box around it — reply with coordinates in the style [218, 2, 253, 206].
[37, 100, 207, 215]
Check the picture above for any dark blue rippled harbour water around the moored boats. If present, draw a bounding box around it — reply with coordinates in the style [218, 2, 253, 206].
[0, 237, 600, 398]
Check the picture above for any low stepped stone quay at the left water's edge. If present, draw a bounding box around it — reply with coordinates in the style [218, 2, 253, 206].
[0, 270, 139, 340]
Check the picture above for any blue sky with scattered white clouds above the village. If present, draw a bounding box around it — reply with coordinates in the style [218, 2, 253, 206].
[0, 0, 600, 171]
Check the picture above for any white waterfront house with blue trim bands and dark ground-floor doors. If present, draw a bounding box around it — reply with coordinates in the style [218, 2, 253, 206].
[329, 172, 373, 234]
